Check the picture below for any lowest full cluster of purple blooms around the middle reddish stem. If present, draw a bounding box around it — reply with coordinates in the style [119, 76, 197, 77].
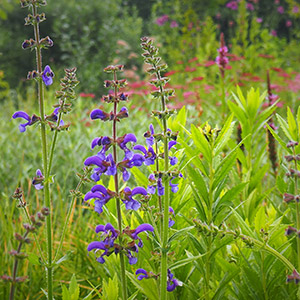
[87, 223, 154, 265]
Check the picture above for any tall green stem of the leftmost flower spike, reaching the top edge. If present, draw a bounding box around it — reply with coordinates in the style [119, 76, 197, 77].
[32, 4, 53, 300]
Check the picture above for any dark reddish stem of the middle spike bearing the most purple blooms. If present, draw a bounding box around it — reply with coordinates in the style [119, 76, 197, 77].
[113, 71, 127, 300]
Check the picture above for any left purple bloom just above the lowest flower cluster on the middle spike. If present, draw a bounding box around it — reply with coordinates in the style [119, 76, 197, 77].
[84, 184, 115, 214]
